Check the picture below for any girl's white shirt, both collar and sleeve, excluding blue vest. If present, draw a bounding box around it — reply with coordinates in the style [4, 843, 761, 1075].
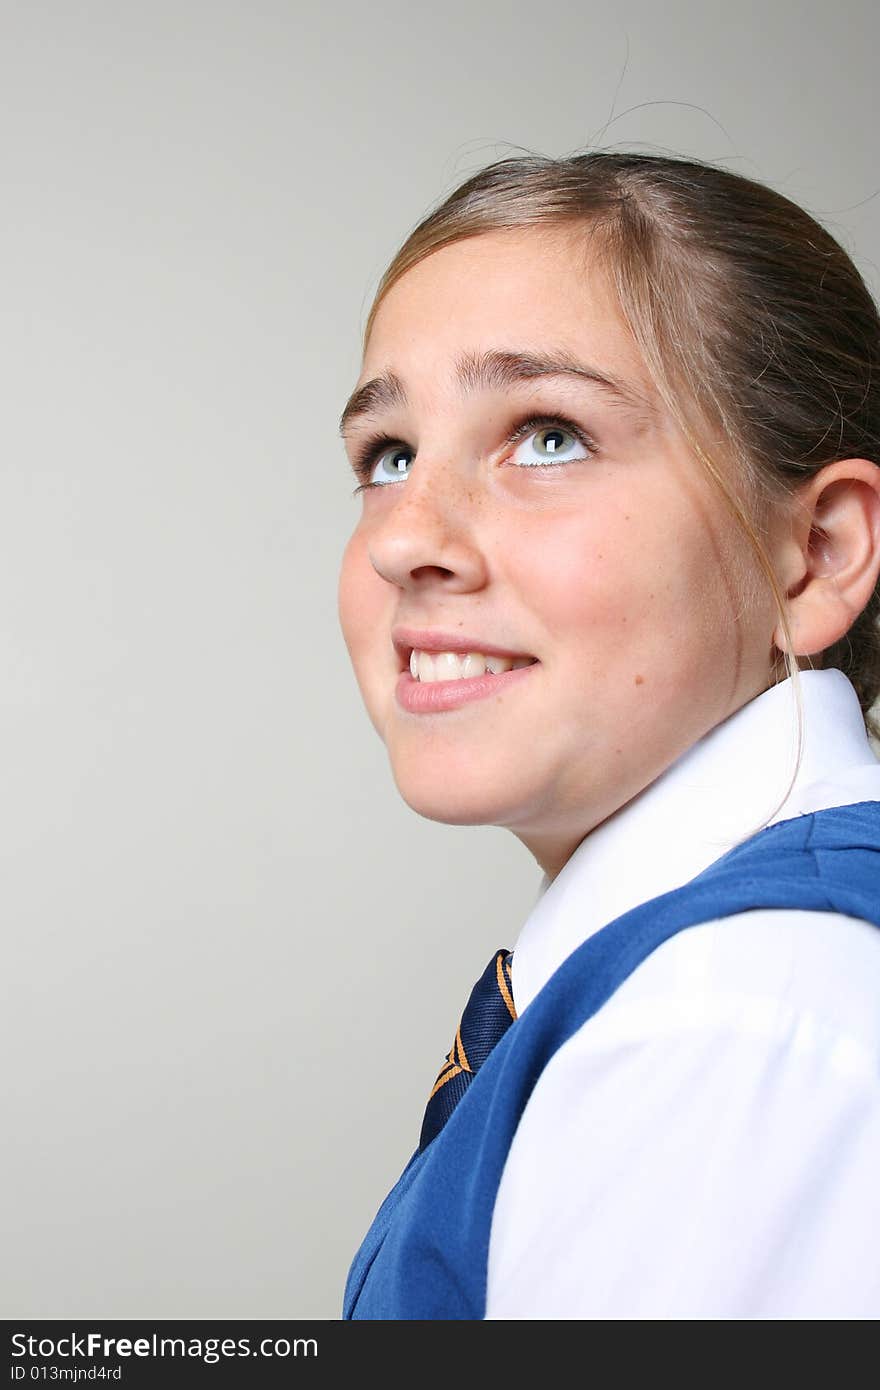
[485, 670, 880, 1319]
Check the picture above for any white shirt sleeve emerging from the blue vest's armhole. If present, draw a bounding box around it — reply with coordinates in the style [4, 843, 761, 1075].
[488, 909, 880, 1316]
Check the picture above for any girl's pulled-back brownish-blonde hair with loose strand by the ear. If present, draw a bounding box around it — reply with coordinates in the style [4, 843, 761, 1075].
[364, 150, 880, 819]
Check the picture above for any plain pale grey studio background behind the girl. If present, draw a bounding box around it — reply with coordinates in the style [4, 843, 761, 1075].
[0, 0, 880, 1318]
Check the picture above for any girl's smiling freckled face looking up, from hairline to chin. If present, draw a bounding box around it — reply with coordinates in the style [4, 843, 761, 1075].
[339, 228, 776, 877]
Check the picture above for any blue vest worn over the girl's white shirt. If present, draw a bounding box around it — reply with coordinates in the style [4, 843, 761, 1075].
[343, 801, 880, 1319]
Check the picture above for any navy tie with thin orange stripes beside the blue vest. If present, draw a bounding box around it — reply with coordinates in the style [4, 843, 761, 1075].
[418, 949, 516, 1152]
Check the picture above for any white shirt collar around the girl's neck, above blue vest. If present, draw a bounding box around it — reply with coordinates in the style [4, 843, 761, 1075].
[513, 669, 880, 1013]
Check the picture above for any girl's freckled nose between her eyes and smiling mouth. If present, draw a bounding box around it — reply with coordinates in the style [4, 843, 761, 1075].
[368, 459, 487, 594]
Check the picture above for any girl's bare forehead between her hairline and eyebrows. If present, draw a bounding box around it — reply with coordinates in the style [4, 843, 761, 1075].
[361, 227, 653, 395]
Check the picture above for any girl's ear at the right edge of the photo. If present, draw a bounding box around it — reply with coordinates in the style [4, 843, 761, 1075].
[773, 459, 880, 656]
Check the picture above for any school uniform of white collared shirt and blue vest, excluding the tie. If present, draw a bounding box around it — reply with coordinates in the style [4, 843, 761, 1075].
[345, 670, 880, 1319]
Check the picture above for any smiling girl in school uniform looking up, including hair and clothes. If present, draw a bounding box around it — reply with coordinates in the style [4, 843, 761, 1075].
[339, 153, 880, 1319]
